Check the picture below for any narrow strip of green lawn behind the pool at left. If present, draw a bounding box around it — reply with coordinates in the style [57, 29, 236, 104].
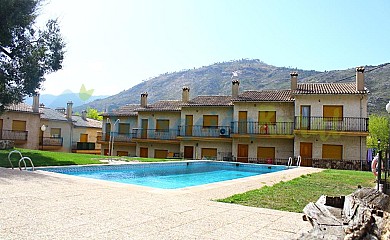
[0, 148, 181, 168]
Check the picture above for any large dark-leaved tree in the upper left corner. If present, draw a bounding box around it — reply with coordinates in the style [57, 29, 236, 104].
[0, 0, 65, 113]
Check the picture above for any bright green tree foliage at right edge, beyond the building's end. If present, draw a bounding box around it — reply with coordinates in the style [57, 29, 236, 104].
[367, 114, 390, 150]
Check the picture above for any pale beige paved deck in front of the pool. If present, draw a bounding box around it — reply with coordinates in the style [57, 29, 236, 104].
[0, 167, 321, 240]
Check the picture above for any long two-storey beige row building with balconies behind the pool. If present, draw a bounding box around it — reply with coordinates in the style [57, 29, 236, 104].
[102, 67, 368, 167]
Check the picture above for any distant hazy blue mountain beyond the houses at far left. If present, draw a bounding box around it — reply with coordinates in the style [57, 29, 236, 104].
[25, 91, 108, 108]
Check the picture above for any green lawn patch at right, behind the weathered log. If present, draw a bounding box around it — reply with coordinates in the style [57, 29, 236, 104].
[218, 170, 375, 213]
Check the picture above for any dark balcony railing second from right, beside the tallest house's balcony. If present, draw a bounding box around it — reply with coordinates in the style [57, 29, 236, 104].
[232, 122, 294, 135]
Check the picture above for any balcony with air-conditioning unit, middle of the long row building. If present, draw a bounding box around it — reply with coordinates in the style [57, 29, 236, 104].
[180, 125, 231, 138]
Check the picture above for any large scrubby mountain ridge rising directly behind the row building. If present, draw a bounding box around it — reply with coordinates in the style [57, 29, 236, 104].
[75, 59, 390, 113]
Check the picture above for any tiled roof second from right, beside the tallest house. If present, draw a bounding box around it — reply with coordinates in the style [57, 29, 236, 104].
[233, 90, 294, 102]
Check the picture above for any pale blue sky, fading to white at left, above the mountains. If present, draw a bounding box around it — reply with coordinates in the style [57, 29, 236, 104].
[37, 0, 390, 95]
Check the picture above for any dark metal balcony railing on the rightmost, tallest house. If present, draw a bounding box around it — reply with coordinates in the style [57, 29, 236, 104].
[295, 116, 368, 132]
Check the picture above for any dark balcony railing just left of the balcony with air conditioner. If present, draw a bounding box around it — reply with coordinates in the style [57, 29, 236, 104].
[133, 128, 179, 141]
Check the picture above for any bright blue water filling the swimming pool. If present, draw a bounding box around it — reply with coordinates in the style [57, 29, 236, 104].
[40, 161, 287, 189]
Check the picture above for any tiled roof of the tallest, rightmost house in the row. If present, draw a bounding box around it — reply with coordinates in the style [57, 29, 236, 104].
[293, 83, 367, 95]
